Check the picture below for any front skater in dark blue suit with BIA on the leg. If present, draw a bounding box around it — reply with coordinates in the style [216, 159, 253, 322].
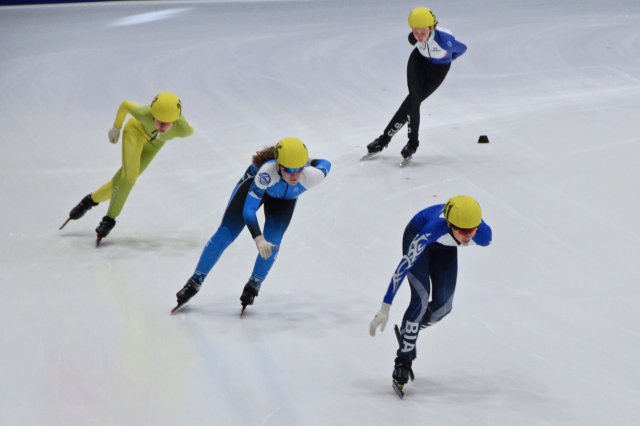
[369, 195, 491, 396]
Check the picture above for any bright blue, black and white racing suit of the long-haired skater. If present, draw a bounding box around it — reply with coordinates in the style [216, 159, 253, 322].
[191, 159, 331, 286]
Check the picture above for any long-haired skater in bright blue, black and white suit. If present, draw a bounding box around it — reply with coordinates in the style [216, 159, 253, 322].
[172, 138, 331, 312]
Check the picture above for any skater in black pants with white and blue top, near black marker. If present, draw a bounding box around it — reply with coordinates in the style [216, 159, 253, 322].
[367, 7, 467, 160]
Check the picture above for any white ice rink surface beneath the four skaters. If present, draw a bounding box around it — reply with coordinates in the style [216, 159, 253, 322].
[0, 0, 640, 426]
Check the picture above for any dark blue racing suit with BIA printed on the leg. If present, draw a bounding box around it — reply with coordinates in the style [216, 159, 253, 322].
[384, 204, 491, 359]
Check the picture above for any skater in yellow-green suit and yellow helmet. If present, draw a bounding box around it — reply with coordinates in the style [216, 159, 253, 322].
[60, 92, 193, 244]
